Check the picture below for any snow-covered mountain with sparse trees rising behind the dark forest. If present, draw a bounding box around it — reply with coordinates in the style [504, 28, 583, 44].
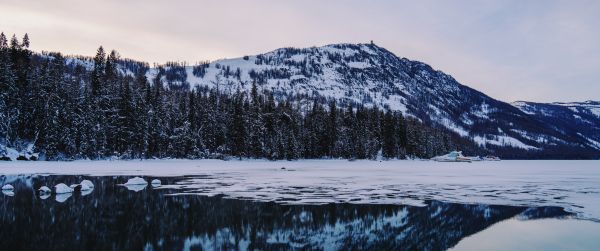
[146, 44, 598, 153]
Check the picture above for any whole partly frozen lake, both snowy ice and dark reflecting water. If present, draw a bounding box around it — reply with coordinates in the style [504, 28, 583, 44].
[0, 160, 600, 250]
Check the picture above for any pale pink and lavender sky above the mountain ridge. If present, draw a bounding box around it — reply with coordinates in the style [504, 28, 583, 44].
[0, 0, 600, 102]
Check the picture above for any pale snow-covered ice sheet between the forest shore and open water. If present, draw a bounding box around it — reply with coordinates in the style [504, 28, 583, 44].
[0, 160, 600, 220]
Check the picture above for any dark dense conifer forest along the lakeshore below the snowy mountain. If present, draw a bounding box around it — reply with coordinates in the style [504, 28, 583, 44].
[0, 34, 488, 160]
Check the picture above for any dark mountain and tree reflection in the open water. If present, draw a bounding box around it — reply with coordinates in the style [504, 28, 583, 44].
[0, 176, 568, 250]
